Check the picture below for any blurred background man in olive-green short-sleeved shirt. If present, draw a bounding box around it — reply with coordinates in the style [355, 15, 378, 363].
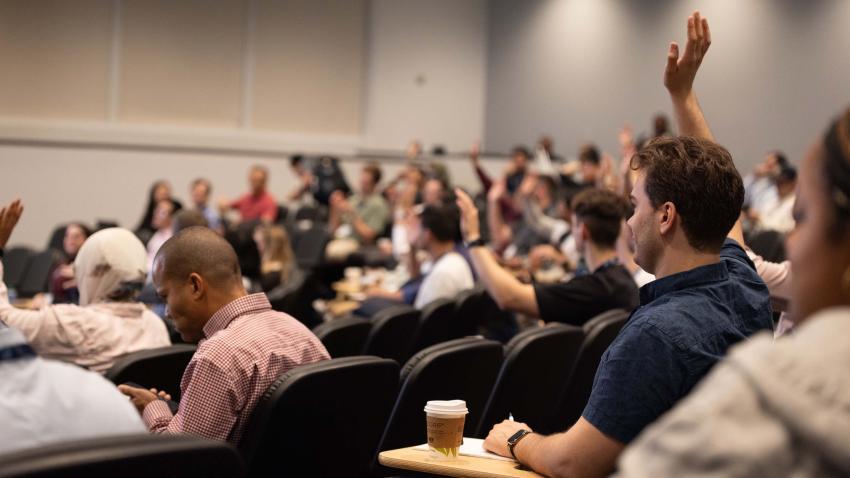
[328, 163, 391, 259]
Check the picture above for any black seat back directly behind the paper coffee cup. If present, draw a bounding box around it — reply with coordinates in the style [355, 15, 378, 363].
[379, 337, 502, 451]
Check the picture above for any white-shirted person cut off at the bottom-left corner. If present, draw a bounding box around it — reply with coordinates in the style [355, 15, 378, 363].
[0, 320, 145, 454]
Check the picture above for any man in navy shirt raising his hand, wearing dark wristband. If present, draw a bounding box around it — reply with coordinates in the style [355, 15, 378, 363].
[476, 13, 773, 476]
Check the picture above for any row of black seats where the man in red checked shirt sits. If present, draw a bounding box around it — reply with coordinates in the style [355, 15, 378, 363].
[74, 311, 628, 476]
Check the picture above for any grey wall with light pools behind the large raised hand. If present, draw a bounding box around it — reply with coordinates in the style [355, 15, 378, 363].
[485, 0, 850, 170]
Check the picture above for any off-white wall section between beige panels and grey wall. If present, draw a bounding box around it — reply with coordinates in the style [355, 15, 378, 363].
[363, 0, 487, 150]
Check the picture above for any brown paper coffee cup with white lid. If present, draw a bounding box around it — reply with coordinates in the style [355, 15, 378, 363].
[425, 400, 469, 460]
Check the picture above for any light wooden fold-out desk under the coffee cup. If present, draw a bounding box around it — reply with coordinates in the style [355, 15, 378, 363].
[378, 447, 540, 478]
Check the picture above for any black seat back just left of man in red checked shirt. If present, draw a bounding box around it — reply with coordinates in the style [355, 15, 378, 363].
[104, 344, 196, 402]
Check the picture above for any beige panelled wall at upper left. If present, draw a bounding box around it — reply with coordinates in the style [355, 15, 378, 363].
[0, 0, 367, 133]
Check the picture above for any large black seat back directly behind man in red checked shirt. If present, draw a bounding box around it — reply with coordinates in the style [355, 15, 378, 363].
[240, 356, 399, 477]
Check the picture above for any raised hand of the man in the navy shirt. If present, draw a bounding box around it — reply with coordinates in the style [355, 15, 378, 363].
[664, 12, 711, 98]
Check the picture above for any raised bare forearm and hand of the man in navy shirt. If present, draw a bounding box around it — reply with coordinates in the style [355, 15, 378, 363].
[664, 12, 714, 141]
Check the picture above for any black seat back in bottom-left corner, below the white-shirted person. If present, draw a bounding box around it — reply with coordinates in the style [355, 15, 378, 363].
[0, 433, 244, 478]
